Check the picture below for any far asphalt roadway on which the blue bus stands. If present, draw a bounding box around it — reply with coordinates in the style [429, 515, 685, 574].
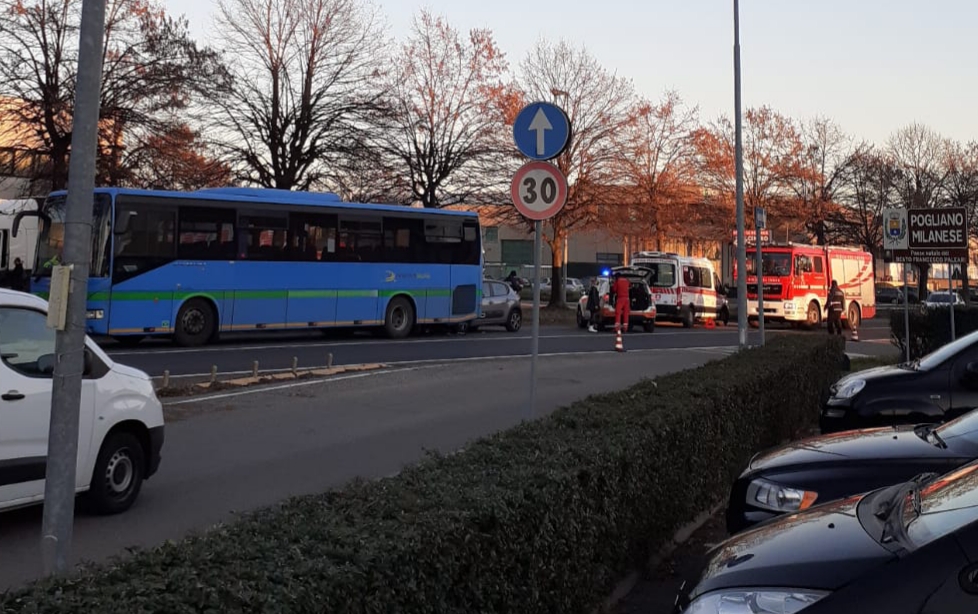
[106, 318, 892, 376]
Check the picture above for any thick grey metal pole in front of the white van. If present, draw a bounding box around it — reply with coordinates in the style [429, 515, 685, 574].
[41, 0, 105, 575]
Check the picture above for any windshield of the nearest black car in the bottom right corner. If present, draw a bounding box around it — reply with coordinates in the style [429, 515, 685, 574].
[903, 462, 978, 547]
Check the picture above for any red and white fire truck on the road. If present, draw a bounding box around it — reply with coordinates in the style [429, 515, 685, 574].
[734, 243, 876, 328]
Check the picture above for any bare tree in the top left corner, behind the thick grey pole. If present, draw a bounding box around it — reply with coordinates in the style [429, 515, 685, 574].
[0, 0, 221, 190]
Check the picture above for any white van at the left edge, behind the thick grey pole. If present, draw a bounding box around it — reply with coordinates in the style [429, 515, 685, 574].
[0, 289, 163, 514]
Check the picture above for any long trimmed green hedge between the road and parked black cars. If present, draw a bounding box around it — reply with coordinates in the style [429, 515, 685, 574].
[0, 336, 842, 614]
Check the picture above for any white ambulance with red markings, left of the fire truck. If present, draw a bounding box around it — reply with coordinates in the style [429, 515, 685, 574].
[630, 252, 730, 328]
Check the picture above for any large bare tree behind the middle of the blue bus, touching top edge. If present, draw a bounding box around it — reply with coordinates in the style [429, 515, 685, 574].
[208, 0, 387, 189]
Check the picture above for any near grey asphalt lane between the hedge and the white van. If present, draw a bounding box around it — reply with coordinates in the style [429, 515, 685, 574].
[0, 346, 732, 589]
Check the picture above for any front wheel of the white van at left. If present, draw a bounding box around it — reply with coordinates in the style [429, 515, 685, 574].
[86, 432, 146, 514]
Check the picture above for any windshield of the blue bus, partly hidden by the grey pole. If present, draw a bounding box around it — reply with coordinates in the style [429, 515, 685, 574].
[34, 194, 112, 277]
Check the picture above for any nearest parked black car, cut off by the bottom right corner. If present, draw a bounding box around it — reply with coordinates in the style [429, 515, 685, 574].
[675, 463, 978, 614]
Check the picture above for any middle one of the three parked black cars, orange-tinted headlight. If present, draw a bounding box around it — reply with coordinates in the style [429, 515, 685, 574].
[727, 410, 978, 533]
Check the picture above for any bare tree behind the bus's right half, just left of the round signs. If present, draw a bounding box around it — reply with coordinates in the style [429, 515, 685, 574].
[376, 11, 512, 207]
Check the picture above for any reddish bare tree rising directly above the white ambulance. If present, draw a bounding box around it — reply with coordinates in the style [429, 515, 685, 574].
[614, 92, 699, 249]
